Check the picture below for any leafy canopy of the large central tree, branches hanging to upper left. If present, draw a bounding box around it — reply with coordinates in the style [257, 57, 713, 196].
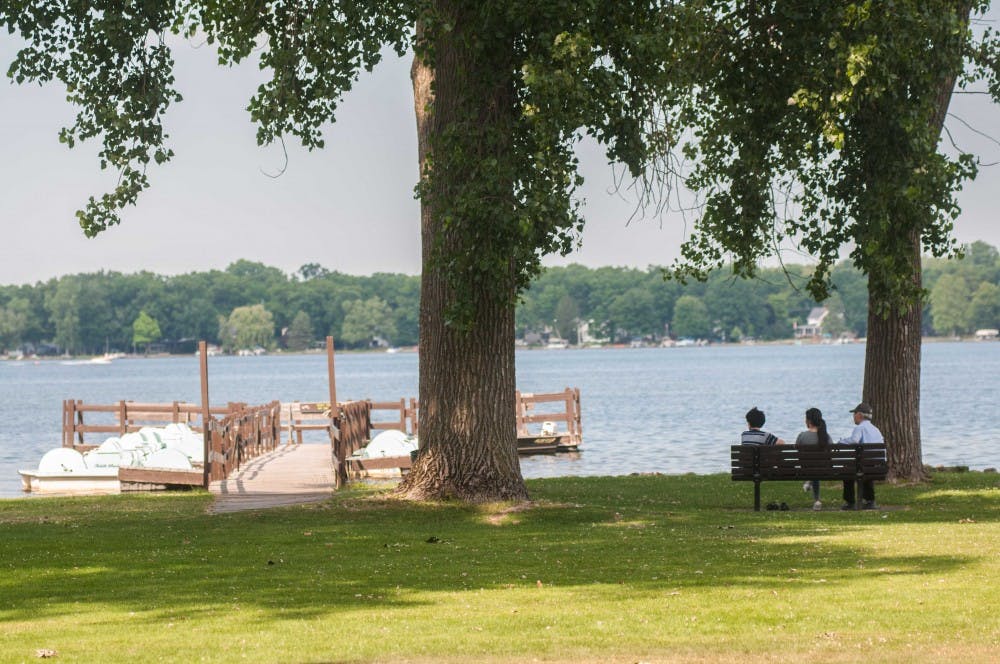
[0, 0, 693, 324]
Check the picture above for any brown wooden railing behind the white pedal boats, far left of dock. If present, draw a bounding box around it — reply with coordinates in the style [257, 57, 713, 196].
[62, 399, 236, 452]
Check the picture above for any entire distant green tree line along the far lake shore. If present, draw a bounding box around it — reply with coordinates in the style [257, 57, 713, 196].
[0, 242, 1000, 354]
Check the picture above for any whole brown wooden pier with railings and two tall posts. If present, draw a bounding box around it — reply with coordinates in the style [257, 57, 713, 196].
[43, 337, 583, 506]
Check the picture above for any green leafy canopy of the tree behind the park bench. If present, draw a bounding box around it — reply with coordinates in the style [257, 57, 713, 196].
[671, 0, 1000, 303]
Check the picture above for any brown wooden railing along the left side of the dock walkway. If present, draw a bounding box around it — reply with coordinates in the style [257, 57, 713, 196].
[205, 401, 281, 488]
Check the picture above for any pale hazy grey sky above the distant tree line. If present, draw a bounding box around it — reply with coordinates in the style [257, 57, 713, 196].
[0, 10, 1000, 284]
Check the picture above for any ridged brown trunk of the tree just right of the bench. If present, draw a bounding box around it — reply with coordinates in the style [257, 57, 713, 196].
[863, 232, 925, 480]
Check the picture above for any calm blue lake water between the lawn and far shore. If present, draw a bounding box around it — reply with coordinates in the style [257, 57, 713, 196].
[0, 342, 1000, 497]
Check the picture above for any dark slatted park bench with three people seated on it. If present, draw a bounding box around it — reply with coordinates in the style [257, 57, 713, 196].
[732, 443, 889, 512]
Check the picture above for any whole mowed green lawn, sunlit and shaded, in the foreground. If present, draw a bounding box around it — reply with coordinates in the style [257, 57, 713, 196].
[0, 473, 1000, 662]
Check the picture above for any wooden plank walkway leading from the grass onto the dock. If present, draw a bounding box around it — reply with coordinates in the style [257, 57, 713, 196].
[209, 443, 333, 513]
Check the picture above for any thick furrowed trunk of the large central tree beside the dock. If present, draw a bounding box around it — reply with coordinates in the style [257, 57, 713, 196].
[397, 11, 528, 502]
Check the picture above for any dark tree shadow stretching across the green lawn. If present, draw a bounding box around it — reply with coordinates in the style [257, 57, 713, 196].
[0, 476, 996, 623]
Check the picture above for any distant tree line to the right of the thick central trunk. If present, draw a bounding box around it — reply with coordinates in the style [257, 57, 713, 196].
[517, 242, 1000, 343]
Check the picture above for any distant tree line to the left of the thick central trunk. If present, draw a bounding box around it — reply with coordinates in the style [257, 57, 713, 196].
[0, 260, 420, 354]
